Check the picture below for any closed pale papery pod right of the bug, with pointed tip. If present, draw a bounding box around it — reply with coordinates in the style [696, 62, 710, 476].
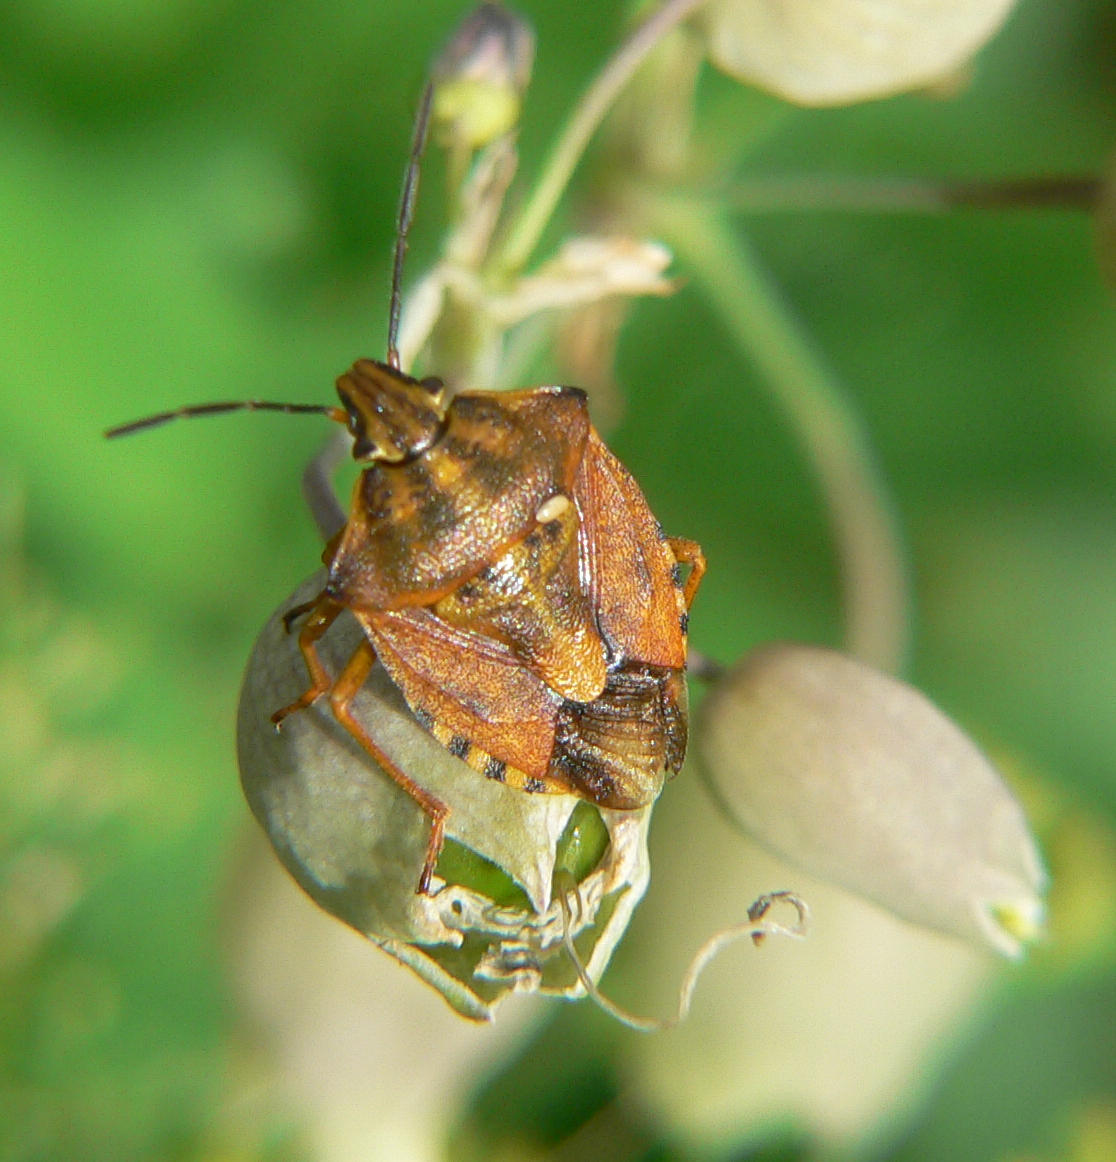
[696, 645, 1045, 956]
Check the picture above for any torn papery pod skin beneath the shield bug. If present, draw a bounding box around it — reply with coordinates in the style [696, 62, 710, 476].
[237, 574, 651, 1020]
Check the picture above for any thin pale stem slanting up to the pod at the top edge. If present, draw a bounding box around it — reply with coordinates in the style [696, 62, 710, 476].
[496, 0, 706, 274]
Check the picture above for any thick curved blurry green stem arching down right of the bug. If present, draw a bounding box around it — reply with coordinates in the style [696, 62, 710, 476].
[646, 196, 909, 670]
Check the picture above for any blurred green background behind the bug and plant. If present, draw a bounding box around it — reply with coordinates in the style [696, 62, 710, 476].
[0, 0, 1116, 1162]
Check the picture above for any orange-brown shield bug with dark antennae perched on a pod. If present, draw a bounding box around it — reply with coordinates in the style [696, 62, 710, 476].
[108, 86, 704, 892]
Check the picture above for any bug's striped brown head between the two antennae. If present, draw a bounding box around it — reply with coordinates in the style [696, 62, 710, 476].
[337, 359, 446, 464]
